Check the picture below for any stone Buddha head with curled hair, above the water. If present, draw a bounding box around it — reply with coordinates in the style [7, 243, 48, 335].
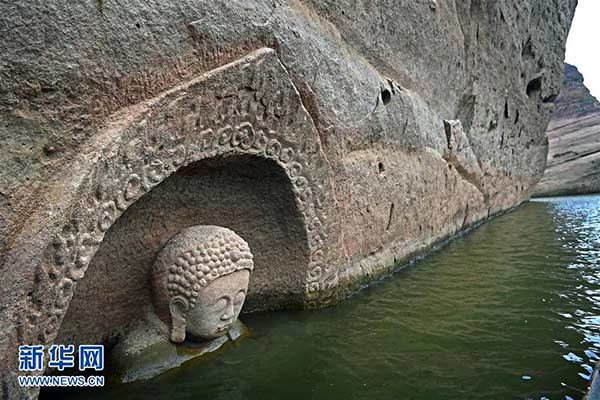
[153, 226, 254, 343]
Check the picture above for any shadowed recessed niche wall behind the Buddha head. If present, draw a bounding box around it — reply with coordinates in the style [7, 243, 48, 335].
[58, 154, 310, 343]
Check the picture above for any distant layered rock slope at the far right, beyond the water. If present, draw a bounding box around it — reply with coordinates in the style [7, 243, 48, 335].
[534, 64, 600, 196]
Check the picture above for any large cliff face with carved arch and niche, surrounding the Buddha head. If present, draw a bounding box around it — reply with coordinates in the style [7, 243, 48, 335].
[0, 0, 576, 397]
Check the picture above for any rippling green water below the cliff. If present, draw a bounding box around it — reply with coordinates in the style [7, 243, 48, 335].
[45, 196, 600, 400]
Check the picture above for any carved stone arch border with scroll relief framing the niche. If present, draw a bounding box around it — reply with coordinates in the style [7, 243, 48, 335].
[19, 49, 338, 344]
